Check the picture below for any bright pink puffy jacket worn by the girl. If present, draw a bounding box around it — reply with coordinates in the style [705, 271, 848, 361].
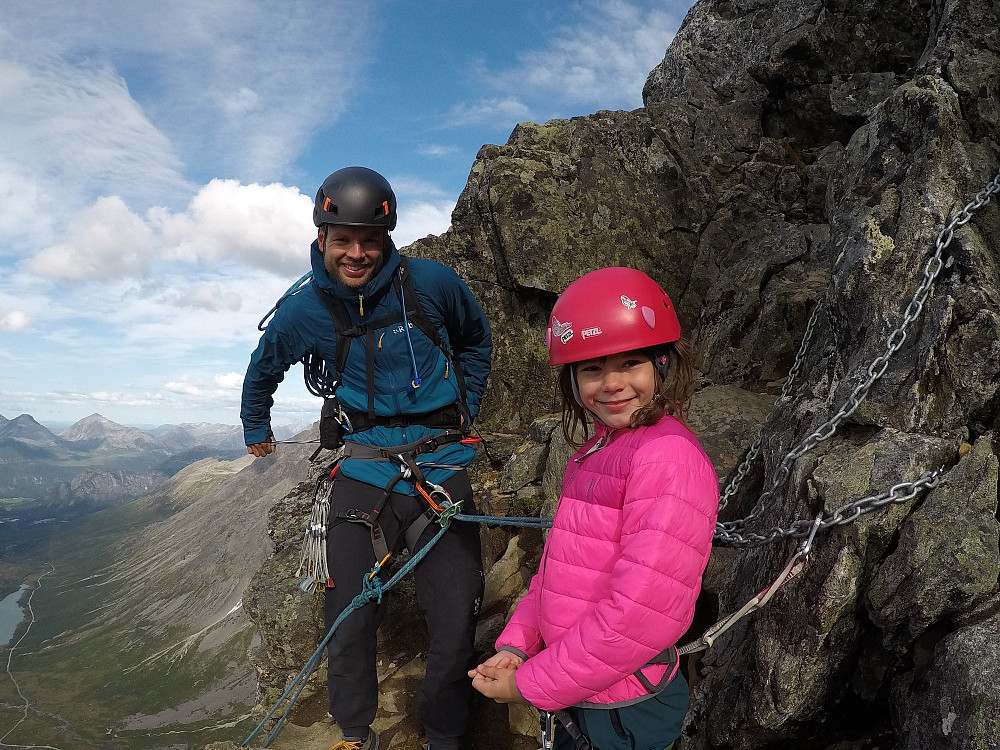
[496, 416, 719, 711]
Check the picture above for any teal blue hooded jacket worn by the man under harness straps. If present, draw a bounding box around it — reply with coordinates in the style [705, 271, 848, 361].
[240, 242, 493, 494]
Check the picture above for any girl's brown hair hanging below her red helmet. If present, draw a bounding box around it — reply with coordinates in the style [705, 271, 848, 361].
[556, 339, 694, 447]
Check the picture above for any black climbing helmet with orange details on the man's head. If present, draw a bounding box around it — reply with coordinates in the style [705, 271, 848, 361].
[313, 167, 396, 232]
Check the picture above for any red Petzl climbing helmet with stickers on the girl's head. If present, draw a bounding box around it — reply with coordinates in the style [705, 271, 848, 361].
[545, 267, 681, 365]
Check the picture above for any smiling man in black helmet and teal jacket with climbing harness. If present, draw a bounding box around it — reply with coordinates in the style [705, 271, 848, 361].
[241, 167, 492, 750]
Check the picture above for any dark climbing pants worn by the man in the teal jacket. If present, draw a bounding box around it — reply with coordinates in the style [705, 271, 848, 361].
[324, 471, 483, 750]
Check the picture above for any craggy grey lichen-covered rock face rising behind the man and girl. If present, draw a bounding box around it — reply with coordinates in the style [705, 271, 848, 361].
[238, 0, 1000, 750]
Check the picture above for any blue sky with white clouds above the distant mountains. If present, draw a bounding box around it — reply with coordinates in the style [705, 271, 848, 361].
[0, 0, 691, 427]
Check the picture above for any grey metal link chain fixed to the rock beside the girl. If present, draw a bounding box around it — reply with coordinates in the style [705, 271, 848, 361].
[715, 173, 1000, 545]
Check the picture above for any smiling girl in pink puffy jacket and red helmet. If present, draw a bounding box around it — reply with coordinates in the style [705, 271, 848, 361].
[469, 268, 719, 750]
